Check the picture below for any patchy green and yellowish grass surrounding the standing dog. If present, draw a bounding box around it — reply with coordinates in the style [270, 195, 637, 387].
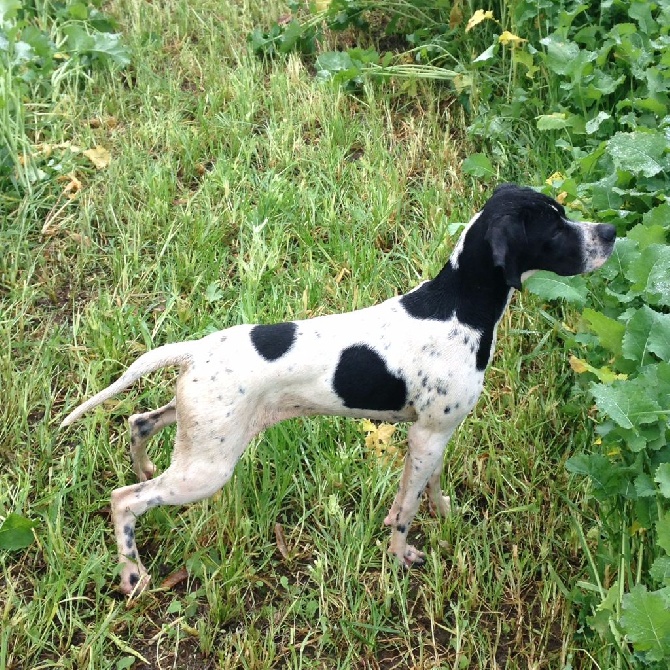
[0, 0, 612, 670]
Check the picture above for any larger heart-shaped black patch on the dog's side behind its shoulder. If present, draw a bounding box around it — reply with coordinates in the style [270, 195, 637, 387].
[333, 344, 407, 411]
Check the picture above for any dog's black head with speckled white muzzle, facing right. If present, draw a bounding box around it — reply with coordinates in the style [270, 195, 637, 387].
[484, 184, 616, 289]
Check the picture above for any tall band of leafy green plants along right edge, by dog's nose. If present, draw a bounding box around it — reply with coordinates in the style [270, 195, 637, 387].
[510, 1, 670, 667]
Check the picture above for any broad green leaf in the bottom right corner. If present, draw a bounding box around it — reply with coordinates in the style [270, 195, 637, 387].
[620, 585, 670, 661]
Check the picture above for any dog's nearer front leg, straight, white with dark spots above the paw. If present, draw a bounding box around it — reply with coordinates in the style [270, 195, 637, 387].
[385, 423, 453, 567]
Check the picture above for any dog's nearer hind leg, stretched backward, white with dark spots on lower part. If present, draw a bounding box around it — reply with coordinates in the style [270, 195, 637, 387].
[112, 424, 250, 594]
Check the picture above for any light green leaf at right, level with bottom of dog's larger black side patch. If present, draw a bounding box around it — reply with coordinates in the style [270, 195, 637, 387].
[591, 380, 661, 429]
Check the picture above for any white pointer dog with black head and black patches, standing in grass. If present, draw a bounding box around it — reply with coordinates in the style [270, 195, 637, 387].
[61, 184, 616, 594]
